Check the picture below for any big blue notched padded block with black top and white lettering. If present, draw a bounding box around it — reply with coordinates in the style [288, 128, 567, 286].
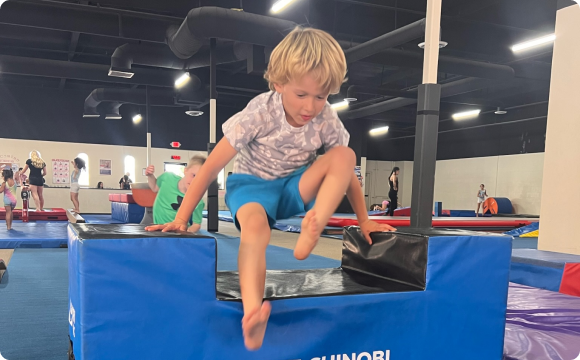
[68, 224, 511, 360]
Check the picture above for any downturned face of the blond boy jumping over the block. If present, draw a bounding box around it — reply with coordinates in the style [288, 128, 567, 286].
[274, 74, 328, 127]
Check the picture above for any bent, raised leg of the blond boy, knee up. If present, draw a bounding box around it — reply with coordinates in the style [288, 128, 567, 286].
[294, 146, 356, 260]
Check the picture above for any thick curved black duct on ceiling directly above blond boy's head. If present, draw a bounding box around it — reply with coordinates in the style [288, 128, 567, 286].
[166, 6, 296, 59]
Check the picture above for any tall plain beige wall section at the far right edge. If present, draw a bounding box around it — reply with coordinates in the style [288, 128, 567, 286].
[538, 5, 580, 255]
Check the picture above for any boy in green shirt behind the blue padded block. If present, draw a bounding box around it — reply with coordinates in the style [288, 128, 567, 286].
[145, 155, 205, 233]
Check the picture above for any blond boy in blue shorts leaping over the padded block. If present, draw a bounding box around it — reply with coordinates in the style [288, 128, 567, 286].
[148, 28, 393, 350]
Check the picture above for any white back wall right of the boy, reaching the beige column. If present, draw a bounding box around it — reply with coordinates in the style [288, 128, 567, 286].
[367, 153, 544, 215]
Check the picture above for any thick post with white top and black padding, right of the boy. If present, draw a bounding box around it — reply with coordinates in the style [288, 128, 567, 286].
[411, 0, 441, 229]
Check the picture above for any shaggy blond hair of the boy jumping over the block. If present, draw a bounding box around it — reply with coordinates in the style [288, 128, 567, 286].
[264, 26, 346, 94]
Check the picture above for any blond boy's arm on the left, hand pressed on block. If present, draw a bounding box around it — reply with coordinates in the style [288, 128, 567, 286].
[146, 136, 237, 232]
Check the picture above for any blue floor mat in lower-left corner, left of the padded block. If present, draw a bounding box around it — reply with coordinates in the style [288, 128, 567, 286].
[0, 249, 68, 360]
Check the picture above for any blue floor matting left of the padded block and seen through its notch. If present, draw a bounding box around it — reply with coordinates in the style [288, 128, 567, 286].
[0, 236, 340, 360]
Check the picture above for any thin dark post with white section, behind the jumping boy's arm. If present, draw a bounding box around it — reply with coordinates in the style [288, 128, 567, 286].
[207, 38, 219, 232]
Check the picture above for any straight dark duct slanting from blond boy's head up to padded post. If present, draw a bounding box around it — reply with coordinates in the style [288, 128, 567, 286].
[344, 19, 425, 63]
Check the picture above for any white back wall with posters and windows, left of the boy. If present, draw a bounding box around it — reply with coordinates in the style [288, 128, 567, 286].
[0, 138, 233, 213]
